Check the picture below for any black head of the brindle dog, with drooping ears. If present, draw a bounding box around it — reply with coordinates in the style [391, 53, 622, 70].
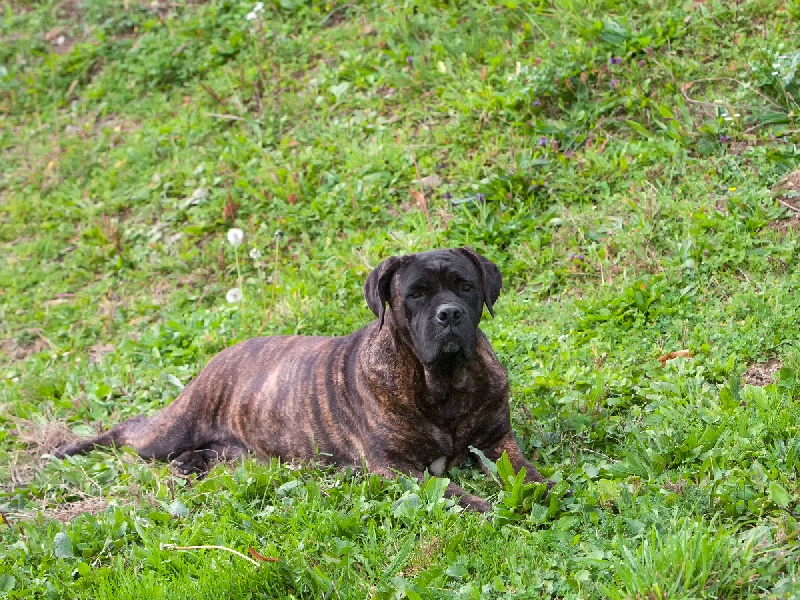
[364, 247, 503, 366]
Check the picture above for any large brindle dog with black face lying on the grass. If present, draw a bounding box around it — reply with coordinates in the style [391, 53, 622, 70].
[58, 248, 544, 511]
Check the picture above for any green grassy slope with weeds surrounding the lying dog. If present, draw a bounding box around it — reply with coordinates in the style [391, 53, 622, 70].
[0, 0, 800, 598]
